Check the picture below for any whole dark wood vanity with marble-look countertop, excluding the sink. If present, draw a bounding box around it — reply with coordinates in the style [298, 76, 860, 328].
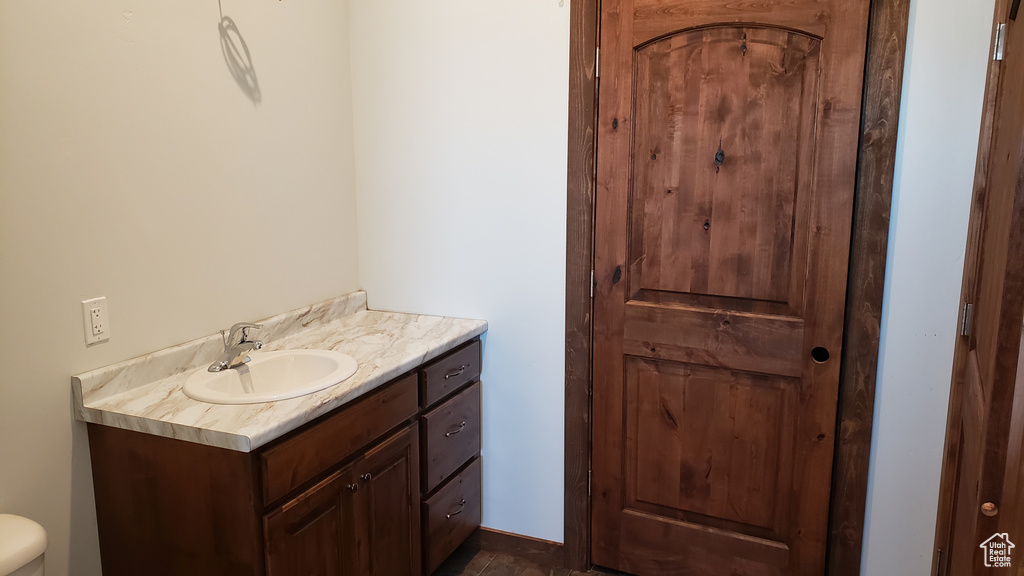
[73, 295, 486, 576]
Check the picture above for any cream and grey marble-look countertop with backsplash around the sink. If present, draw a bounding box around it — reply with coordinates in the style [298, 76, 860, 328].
[72, 292, 487, 452]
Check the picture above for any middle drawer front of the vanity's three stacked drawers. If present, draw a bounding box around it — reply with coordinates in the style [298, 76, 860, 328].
[421, 382, 480, 493]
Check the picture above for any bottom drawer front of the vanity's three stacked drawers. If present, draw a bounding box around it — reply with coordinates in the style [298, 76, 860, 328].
[423, 458, 481, 574]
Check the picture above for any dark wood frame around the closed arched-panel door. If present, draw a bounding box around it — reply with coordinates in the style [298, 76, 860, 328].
[563, 0, 909, 576]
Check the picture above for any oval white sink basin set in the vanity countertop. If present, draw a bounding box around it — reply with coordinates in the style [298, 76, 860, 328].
[184, 349, 356, 404]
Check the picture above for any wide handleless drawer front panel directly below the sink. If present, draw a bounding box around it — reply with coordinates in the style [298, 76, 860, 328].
[259, 374, 418, 505]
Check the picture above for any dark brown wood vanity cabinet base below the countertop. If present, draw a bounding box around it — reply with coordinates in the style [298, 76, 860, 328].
[89, 340, 481, 576]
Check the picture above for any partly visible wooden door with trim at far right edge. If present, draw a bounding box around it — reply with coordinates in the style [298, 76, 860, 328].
[935, 0, 1024, 576]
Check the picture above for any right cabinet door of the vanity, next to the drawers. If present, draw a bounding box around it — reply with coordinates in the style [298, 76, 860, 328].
[352, 424, 421, 576]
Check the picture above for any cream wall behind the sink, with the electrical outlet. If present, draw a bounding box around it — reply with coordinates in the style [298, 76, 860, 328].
[0, 0, 358, 576]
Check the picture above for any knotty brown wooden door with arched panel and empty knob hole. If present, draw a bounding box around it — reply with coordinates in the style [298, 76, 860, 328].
[592, 0, 868, 576]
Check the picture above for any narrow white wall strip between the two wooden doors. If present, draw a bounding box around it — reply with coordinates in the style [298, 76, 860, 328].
[861, 0, 993, 576]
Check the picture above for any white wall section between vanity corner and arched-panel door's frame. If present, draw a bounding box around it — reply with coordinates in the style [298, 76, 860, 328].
[351, 0, 568, 540]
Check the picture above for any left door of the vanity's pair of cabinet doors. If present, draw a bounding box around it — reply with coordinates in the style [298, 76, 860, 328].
[264, 468, 358, 576]
